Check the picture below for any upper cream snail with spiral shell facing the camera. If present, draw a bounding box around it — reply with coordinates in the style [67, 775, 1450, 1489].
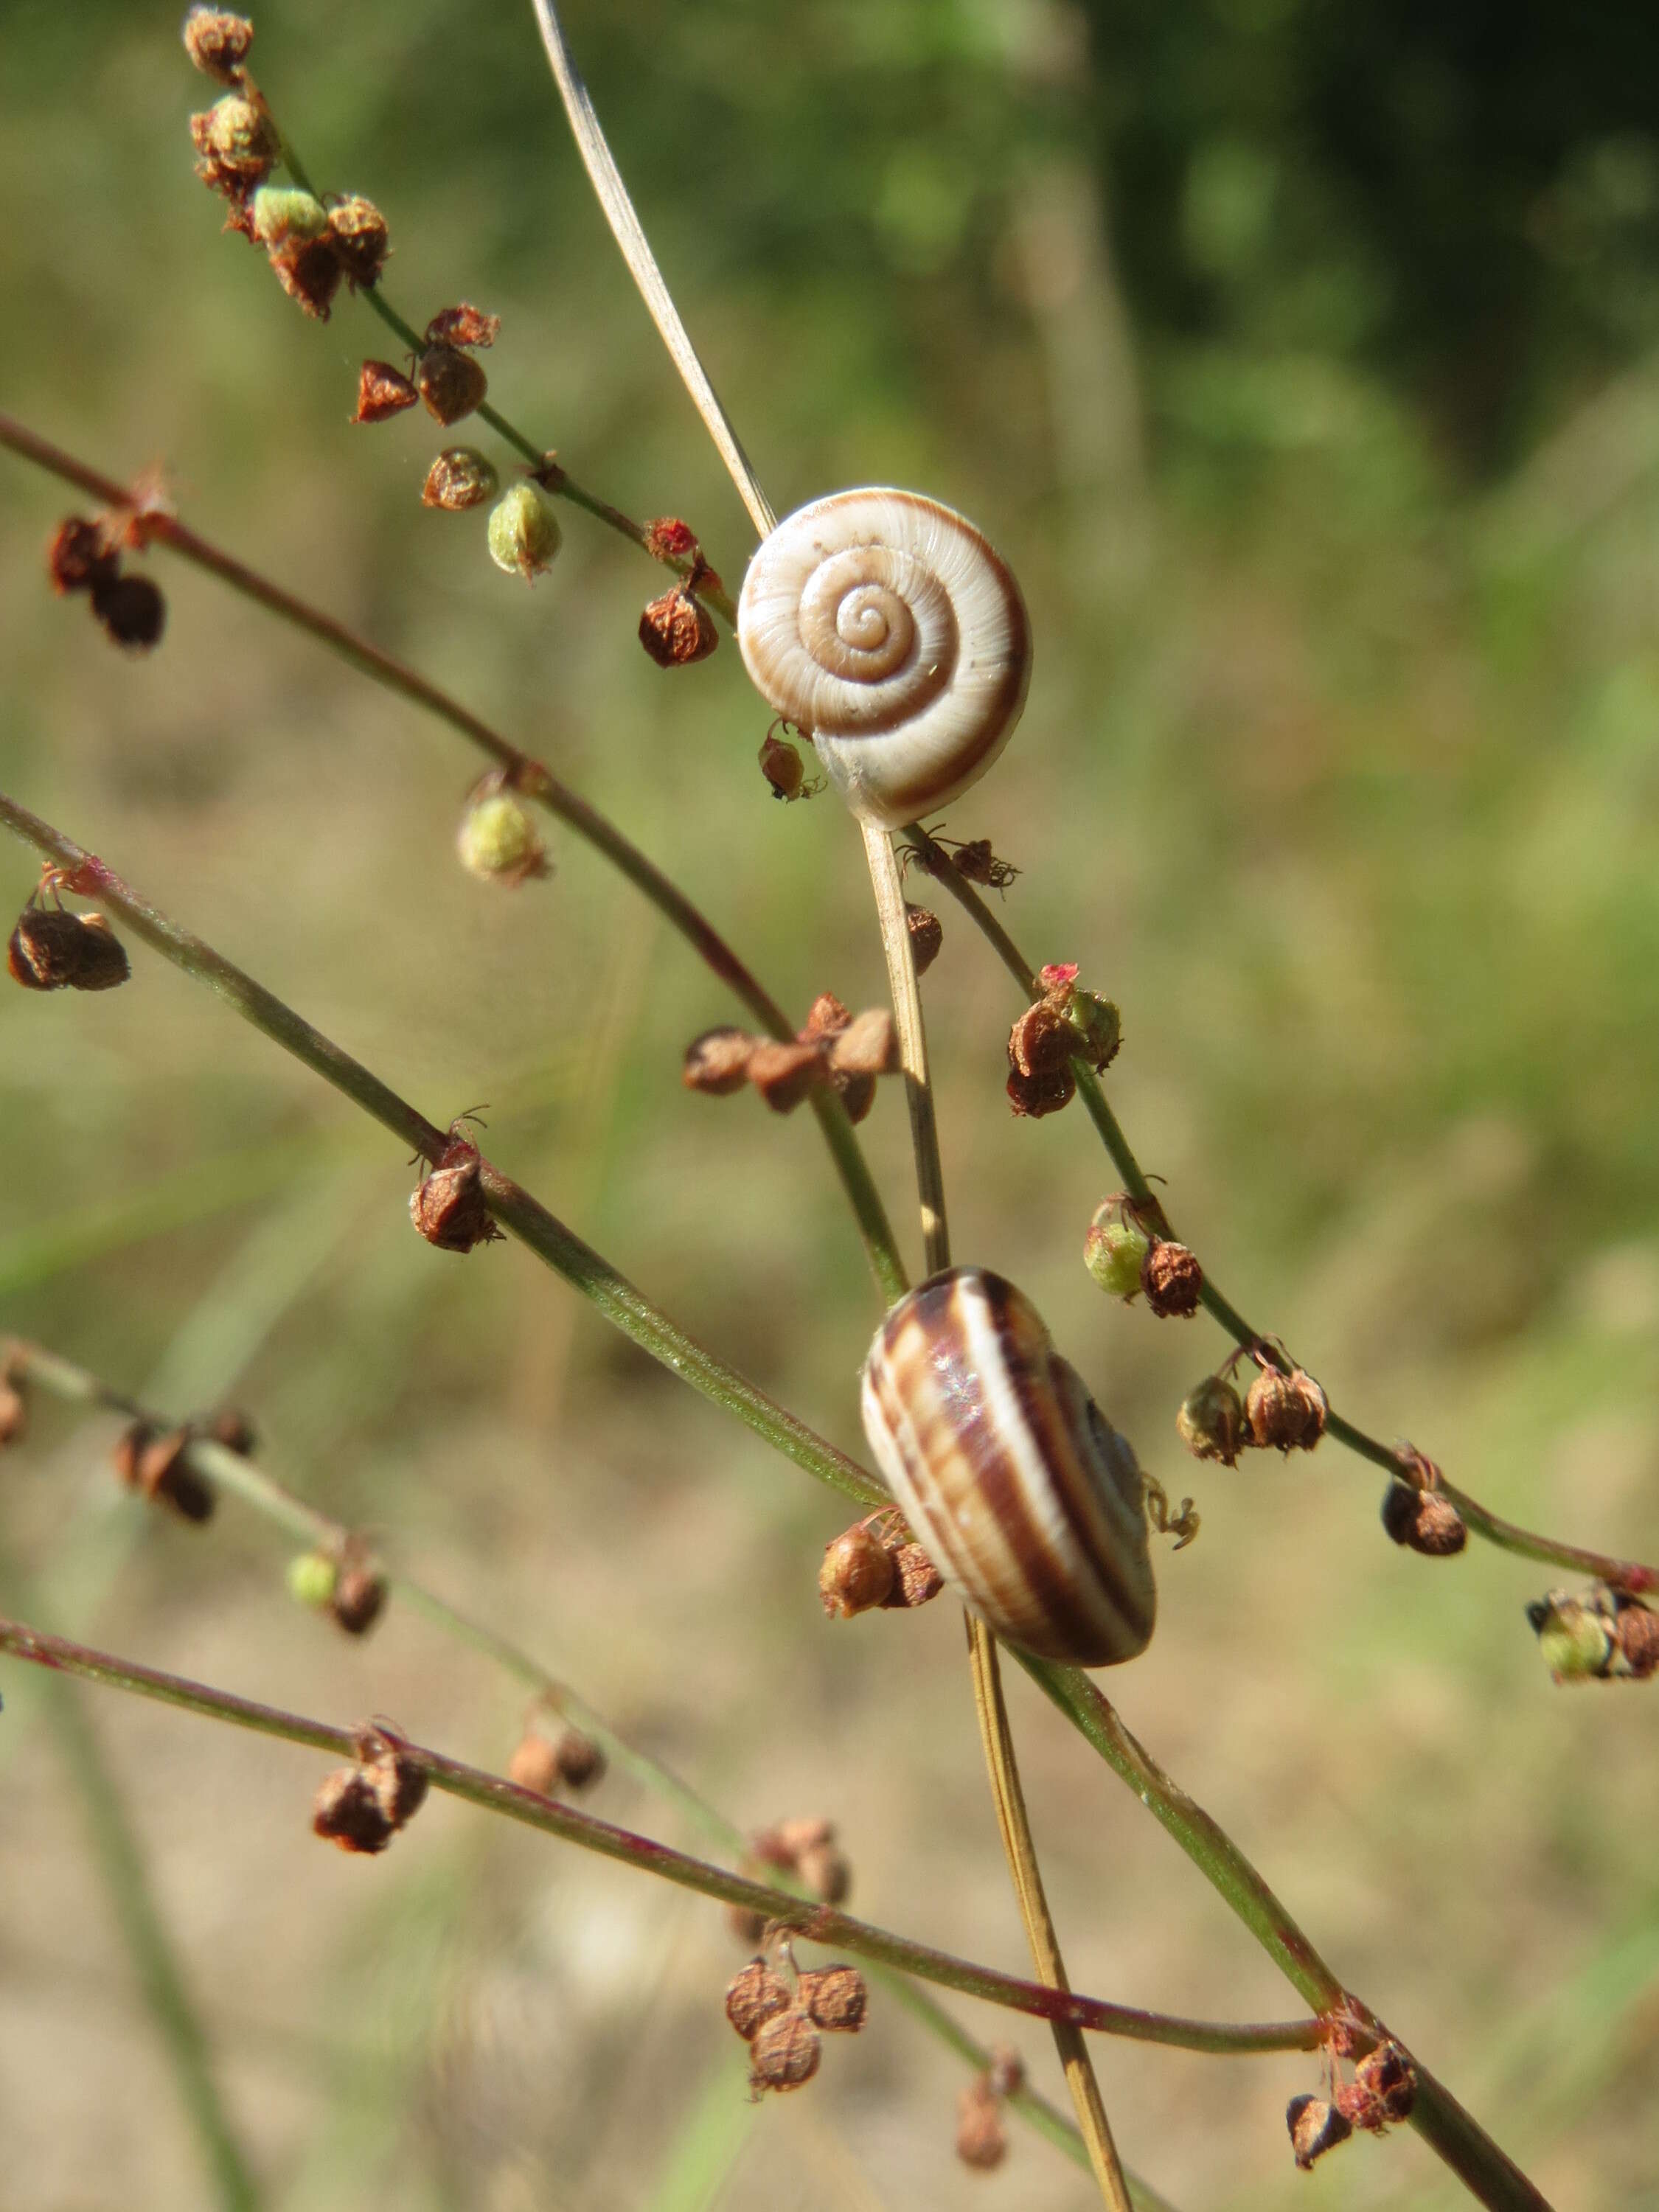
[737, 489, 1031, 830]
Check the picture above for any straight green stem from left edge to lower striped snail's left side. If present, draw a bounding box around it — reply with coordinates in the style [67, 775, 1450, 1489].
[0, 792, 891, 1509]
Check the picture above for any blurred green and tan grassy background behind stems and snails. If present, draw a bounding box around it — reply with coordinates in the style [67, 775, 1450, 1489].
[0, 0, 1659, 2212]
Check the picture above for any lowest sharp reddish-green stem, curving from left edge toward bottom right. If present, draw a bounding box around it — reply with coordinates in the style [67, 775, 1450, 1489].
[0, 1619, 1325, 2057]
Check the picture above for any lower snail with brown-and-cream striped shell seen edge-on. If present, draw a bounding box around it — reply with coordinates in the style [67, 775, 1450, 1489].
[863, 1267, 1157, 1666]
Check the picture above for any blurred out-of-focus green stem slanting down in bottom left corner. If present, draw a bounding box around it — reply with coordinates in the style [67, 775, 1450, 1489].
[0, 1562, 261, 2212]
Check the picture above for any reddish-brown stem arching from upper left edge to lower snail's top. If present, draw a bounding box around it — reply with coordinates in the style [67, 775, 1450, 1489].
[0, 414, 907, 1303]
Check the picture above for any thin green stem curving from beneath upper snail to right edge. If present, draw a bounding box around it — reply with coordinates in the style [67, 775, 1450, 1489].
[902, 823, 1659, 1597]
